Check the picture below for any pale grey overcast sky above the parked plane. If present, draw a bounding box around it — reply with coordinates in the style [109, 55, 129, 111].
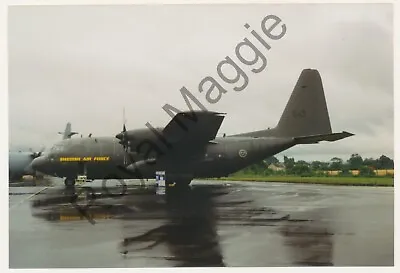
[8, 4, 394, 160]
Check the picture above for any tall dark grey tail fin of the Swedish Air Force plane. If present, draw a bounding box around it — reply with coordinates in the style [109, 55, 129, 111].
[275, 69, 332, 137]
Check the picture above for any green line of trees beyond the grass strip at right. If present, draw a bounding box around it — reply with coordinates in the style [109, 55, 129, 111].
[239, 153, 394, 176]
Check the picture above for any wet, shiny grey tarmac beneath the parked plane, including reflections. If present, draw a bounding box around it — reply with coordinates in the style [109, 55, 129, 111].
[9, 178, 394, 268]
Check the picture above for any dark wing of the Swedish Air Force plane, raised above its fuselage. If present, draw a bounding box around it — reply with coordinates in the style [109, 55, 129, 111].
[162, 111, 225, 151]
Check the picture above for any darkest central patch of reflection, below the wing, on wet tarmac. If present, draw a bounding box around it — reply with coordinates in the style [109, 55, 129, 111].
[121, 187, 225, 267]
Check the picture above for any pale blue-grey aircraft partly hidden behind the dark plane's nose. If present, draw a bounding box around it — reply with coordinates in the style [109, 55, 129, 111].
[8, 122, 77, 181]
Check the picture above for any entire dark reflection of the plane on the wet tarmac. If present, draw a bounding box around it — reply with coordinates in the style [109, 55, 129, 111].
[32, 181, 333, 267]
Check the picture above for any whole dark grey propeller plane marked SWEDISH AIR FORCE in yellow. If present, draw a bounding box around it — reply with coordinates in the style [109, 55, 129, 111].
[32, 69, 353, 186]
